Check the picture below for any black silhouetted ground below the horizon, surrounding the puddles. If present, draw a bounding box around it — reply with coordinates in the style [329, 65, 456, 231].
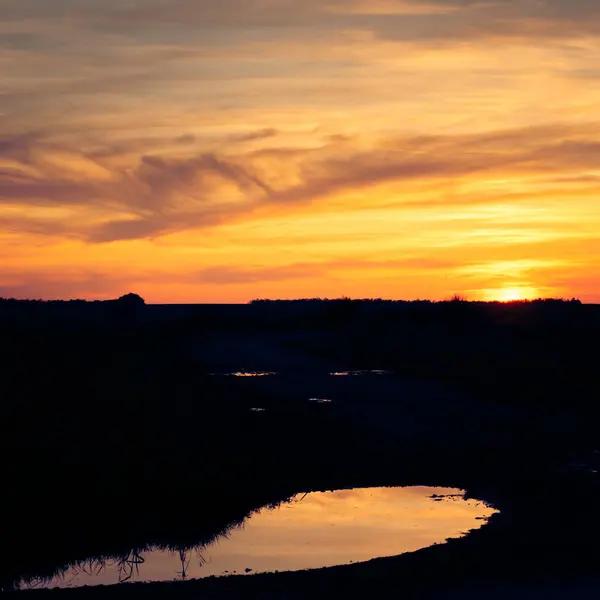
[0, 302, 600, 599]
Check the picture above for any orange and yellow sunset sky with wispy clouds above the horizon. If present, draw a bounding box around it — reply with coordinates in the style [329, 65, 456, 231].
[0, 0, 600, 302]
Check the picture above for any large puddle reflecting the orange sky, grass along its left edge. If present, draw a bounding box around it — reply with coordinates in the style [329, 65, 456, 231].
[22, 487, 496, 589]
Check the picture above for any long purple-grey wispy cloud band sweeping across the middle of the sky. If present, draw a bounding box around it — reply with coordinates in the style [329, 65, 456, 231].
[0, 126, 600, 242]
